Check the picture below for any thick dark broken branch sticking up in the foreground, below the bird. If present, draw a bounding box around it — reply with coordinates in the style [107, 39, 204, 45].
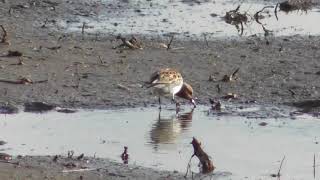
[185, 137, 215, 177]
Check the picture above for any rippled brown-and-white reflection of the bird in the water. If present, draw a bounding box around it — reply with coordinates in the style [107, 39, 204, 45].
[150, 109, 194, 150]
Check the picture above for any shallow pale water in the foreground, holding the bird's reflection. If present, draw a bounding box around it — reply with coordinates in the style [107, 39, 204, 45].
[0, 106, 320, 179]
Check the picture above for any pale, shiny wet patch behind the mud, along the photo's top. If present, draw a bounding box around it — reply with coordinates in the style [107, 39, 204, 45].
[59, 0, 320, 38]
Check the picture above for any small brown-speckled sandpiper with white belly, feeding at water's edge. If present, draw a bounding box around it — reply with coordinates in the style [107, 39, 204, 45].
[147, 68, 196, 109]
